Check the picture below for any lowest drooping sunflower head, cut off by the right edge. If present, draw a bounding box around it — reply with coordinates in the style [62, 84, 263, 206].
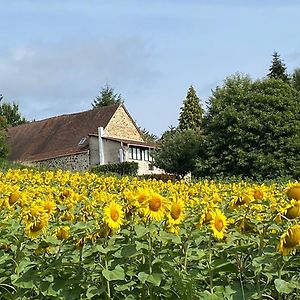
[278, 224, 300, 255]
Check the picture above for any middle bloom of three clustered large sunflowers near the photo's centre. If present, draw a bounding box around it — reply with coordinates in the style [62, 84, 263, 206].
[144, 193, 166, 221]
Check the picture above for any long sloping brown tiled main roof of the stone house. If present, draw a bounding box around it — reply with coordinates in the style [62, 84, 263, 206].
[8, 104, 120, 161]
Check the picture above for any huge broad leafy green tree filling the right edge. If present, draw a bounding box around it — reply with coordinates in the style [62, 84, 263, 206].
[197, 75, 300, 179]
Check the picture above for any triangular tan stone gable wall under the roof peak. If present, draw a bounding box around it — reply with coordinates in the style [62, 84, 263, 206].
[104, 106, 143, 141]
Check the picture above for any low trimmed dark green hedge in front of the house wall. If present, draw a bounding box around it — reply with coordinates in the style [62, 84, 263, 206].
[92, 161, 138, 176]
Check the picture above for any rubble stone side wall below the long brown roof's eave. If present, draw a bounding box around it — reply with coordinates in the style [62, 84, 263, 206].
[35, 152, 90, 171]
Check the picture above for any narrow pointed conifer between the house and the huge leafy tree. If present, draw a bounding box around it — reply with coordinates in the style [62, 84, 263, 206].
[178, 86, 204, 130]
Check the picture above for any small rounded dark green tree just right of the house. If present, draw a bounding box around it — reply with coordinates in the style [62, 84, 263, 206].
[153, 129, 201, 178]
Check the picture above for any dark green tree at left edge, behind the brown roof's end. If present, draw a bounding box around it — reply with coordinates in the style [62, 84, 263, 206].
[0, 95, 27, 127]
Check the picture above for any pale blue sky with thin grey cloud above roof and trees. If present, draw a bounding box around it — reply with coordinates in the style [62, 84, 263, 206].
[0, 0, 300, 136]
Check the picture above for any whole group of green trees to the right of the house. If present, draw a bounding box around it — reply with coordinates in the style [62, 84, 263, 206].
[155, 52, 300, 180]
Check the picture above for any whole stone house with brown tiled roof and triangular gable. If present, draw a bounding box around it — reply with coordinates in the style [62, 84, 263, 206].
[7, 104, 161, 175]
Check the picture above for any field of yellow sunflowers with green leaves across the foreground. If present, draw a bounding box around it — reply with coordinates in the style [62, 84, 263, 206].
[0, 169, 300, 300]
